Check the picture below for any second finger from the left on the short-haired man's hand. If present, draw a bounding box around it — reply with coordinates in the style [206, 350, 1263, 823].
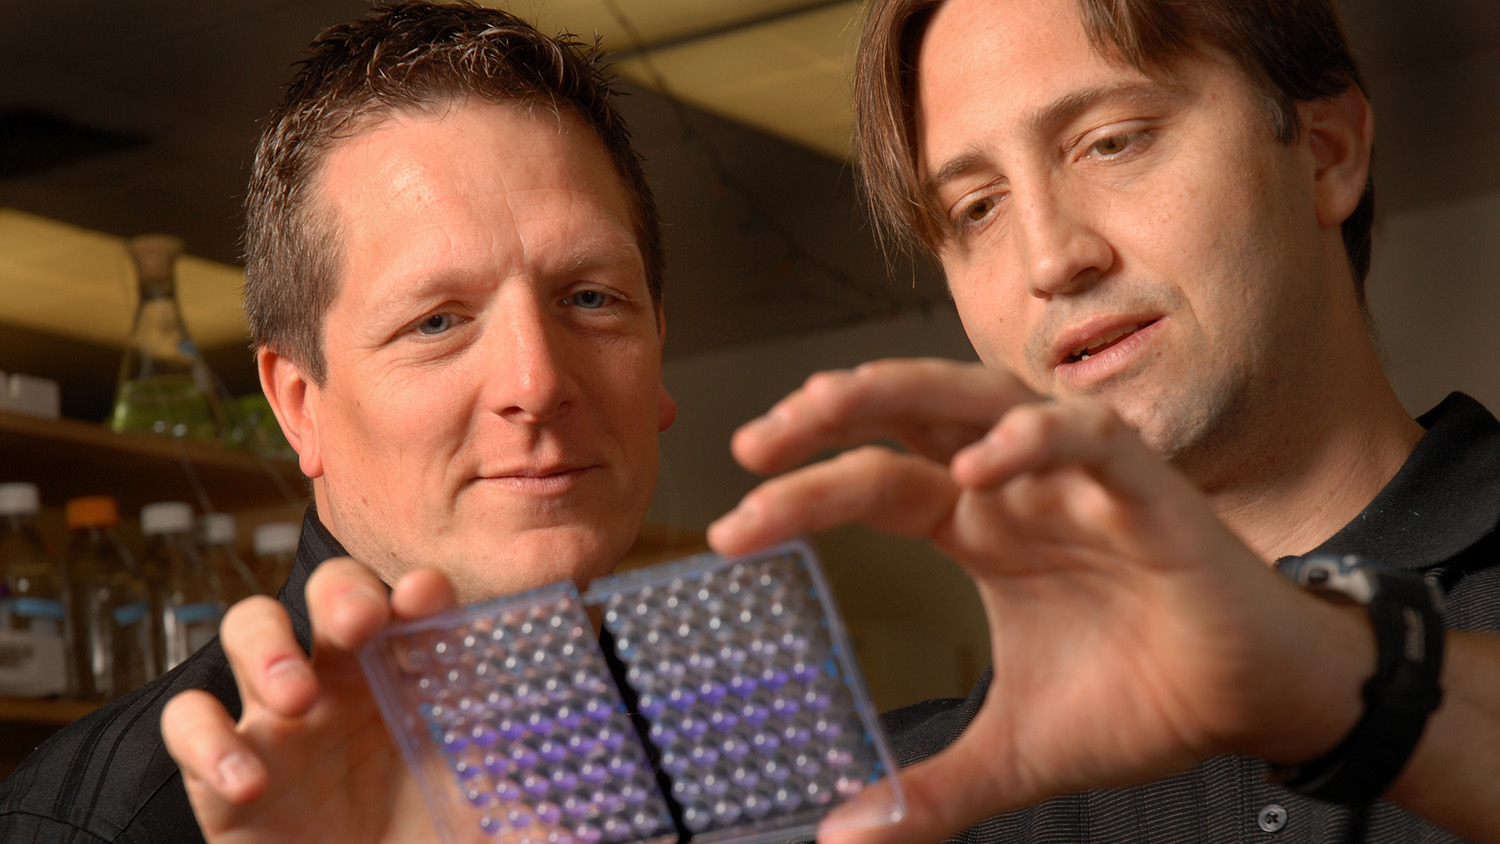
[219, 595, 318, 717]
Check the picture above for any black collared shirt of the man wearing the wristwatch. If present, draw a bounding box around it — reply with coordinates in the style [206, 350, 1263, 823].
[885, 393, 1500, 844]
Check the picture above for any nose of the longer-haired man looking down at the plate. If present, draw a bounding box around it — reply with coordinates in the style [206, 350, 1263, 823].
[1013, 186, 1115, 298]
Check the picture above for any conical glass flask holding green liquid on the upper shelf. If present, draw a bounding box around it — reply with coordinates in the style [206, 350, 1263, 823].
[110, 234, 227, 439]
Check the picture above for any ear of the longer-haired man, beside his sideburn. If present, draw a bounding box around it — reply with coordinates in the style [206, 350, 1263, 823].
[1298, 85, 1376, 228]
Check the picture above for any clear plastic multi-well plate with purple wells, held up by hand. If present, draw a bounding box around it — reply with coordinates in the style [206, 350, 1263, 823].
[360, 543, 905, 844]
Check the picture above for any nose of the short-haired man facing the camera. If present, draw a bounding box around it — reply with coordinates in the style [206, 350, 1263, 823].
[485, 301, 575, 424]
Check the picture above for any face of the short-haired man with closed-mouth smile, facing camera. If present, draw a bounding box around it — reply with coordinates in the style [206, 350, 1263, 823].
[300, 102, 675, 600]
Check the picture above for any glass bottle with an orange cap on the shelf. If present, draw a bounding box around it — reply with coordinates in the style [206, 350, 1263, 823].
[65, 495, 158, 699]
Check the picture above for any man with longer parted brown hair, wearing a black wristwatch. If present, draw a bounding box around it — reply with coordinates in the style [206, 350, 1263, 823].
[710, 0, 1500, 844]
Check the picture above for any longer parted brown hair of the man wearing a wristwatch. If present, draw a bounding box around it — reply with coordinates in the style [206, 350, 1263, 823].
[854, 0, 1376, 296]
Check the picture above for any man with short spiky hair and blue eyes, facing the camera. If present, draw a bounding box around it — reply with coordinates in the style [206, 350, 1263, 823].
[0, 1, 675, 844]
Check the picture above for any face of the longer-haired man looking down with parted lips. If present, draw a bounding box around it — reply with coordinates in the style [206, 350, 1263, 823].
[917, 0, 1352, 459]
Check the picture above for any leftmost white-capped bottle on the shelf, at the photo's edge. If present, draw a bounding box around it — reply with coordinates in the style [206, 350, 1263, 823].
[0, 483, 69, 697]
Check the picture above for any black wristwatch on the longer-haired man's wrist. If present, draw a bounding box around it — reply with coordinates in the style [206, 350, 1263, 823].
[1271, 555, 1443, 805]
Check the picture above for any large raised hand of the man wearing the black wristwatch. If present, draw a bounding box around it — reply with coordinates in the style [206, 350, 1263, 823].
[708, 361, 1374, 844]
